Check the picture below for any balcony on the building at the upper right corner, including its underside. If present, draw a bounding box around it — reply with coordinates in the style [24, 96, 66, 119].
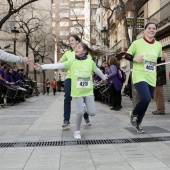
[148, 2, 170, 36]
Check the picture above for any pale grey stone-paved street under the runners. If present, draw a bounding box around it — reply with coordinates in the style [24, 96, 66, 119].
[0, 92, 170, 170]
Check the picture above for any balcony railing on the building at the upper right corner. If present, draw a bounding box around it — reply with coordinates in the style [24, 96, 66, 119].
[148, 2, 170, 29]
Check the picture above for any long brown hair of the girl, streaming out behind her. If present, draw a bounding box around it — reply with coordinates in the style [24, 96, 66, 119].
[78, 42, 105, 60]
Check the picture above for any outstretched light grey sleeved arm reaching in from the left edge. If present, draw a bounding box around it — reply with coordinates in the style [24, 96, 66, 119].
[0, 50, 32, 64]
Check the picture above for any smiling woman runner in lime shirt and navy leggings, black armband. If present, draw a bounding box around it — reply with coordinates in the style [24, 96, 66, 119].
[125, 23, 165, 133]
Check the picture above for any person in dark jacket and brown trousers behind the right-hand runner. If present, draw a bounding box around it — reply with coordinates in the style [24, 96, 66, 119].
[152, 52, 167, 115]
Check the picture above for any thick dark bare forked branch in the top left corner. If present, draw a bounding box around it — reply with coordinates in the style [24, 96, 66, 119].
[0, 0, 38, 29]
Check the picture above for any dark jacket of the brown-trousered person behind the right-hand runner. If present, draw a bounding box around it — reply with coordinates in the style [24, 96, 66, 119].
[156, 62, 166, 86]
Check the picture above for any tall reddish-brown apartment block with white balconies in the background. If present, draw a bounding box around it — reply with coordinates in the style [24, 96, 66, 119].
[52, 0, 90, 81]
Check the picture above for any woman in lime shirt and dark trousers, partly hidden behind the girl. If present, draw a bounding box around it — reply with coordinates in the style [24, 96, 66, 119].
[60, 35, 92, 128]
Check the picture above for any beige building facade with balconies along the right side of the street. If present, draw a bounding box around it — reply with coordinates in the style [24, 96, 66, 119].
[98, 0, 170, 100]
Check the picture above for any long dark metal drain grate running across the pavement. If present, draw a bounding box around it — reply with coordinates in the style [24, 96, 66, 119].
[0, 136, 170, 148]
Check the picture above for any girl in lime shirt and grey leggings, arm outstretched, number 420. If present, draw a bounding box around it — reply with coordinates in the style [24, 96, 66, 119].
[34, 42, 106, 139]
